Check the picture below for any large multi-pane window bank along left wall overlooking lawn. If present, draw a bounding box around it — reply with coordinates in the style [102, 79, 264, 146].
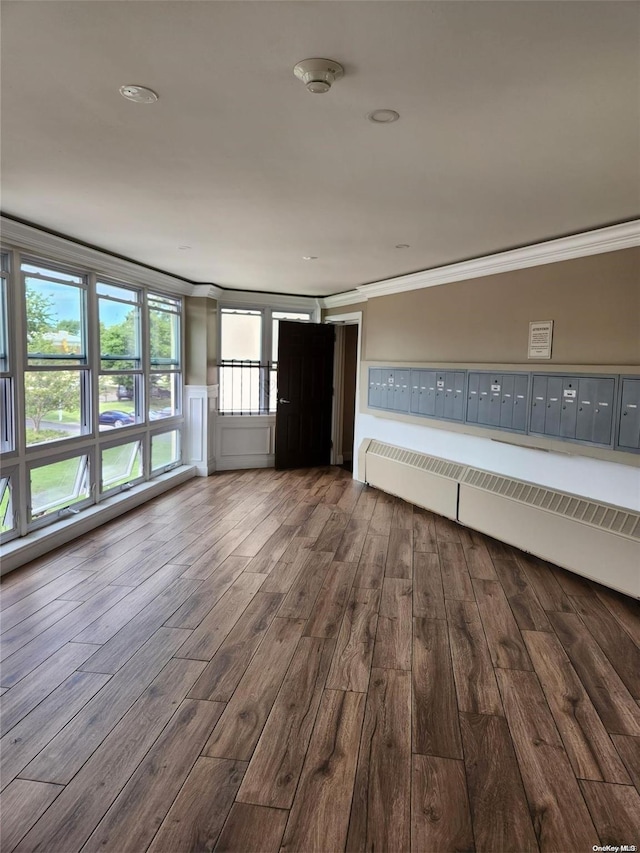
[0, 243, 183, 542]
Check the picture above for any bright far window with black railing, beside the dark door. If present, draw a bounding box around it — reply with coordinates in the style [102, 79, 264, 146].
[218, 308, 311, 415]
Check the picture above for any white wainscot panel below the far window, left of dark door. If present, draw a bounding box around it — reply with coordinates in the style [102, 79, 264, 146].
[215, 414, 276, 471]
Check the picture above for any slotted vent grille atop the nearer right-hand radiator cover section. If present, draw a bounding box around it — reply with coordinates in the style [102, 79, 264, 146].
[461, 468, 640, 540]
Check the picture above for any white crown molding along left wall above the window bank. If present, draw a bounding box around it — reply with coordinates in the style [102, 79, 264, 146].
[0, 216, 198, 296]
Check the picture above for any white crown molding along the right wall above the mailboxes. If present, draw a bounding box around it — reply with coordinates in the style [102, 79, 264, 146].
[348, 219, 640, 308]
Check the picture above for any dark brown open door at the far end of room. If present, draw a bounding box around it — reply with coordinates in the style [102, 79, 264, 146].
[276, 320, 335, 469]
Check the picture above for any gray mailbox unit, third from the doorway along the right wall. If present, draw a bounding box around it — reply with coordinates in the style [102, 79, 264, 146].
[467, 371, 529, 432]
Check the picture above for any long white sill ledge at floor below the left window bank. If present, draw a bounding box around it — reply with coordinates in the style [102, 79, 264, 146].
[0, 465, 196, 575]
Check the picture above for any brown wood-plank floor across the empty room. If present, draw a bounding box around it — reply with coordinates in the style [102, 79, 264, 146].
[0, 468, 640, 853]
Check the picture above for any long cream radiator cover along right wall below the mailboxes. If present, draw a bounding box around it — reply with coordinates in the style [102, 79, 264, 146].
[362, 441, 640, 598]
